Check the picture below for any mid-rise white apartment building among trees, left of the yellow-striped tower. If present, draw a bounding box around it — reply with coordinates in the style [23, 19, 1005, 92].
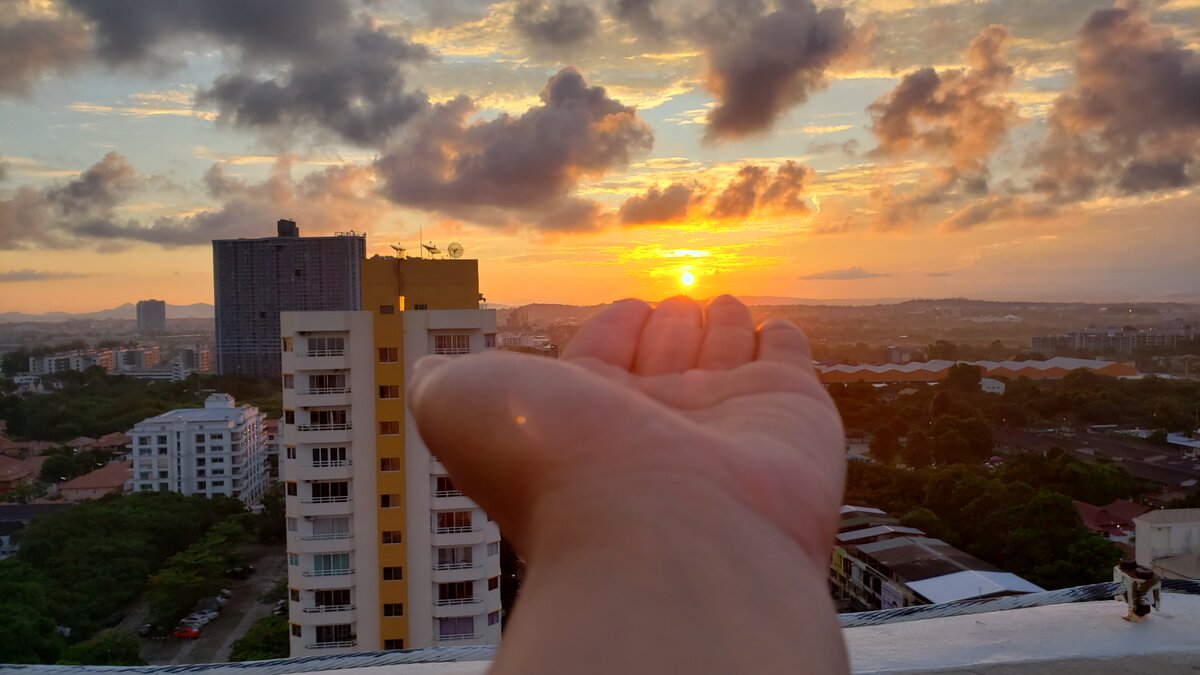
[127, 394, 266, 506]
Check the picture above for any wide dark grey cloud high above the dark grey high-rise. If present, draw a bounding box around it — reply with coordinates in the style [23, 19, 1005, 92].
[197, 26, 432, 147]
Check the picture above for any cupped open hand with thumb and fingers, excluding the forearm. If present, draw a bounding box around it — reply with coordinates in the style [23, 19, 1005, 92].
[413, 297, 845, 565]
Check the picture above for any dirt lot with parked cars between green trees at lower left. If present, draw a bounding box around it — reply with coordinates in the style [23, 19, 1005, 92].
[121, 546, 286, 665]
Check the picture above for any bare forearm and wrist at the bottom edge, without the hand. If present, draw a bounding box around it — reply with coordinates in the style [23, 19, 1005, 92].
[496, 473, 847, 674]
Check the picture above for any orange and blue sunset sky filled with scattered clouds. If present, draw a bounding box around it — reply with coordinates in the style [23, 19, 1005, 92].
[0, 0, 1200, 311]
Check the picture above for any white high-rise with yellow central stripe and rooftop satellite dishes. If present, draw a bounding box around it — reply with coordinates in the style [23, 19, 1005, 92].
[281, 257, 500, 656]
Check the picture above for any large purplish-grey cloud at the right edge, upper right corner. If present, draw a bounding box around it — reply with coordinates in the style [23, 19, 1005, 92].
[1036, 4, 1200, 201]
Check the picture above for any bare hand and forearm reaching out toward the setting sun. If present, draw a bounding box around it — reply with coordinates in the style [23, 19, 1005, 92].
[410, 295, 847, 675]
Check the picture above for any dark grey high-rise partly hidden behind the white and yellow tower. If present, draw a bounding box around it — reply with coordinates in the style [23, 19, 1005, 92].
[212, 220, 366, 376]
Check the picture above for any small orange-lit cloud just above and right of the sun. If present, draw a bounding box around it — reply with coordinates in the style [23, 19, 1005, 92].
[710, 161, 812, 219]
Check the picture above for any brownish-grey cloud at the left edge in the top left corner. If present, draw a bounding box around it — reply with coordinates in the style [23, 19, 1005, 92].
[0, 0, 91, 96]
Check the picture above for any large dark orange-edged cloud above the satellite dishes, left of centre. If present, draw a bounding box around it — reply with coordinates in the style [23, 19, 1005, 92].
[376, 68, 654, 229]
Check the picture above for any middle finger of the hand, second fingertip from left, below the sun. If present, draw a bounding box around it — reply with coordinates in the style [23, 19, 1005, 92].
[634, 295, 704, 375]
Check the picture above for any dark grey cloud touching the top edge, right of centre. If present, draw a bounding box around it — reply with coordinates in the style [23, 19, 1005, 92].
[697, 0, 854, 141]
